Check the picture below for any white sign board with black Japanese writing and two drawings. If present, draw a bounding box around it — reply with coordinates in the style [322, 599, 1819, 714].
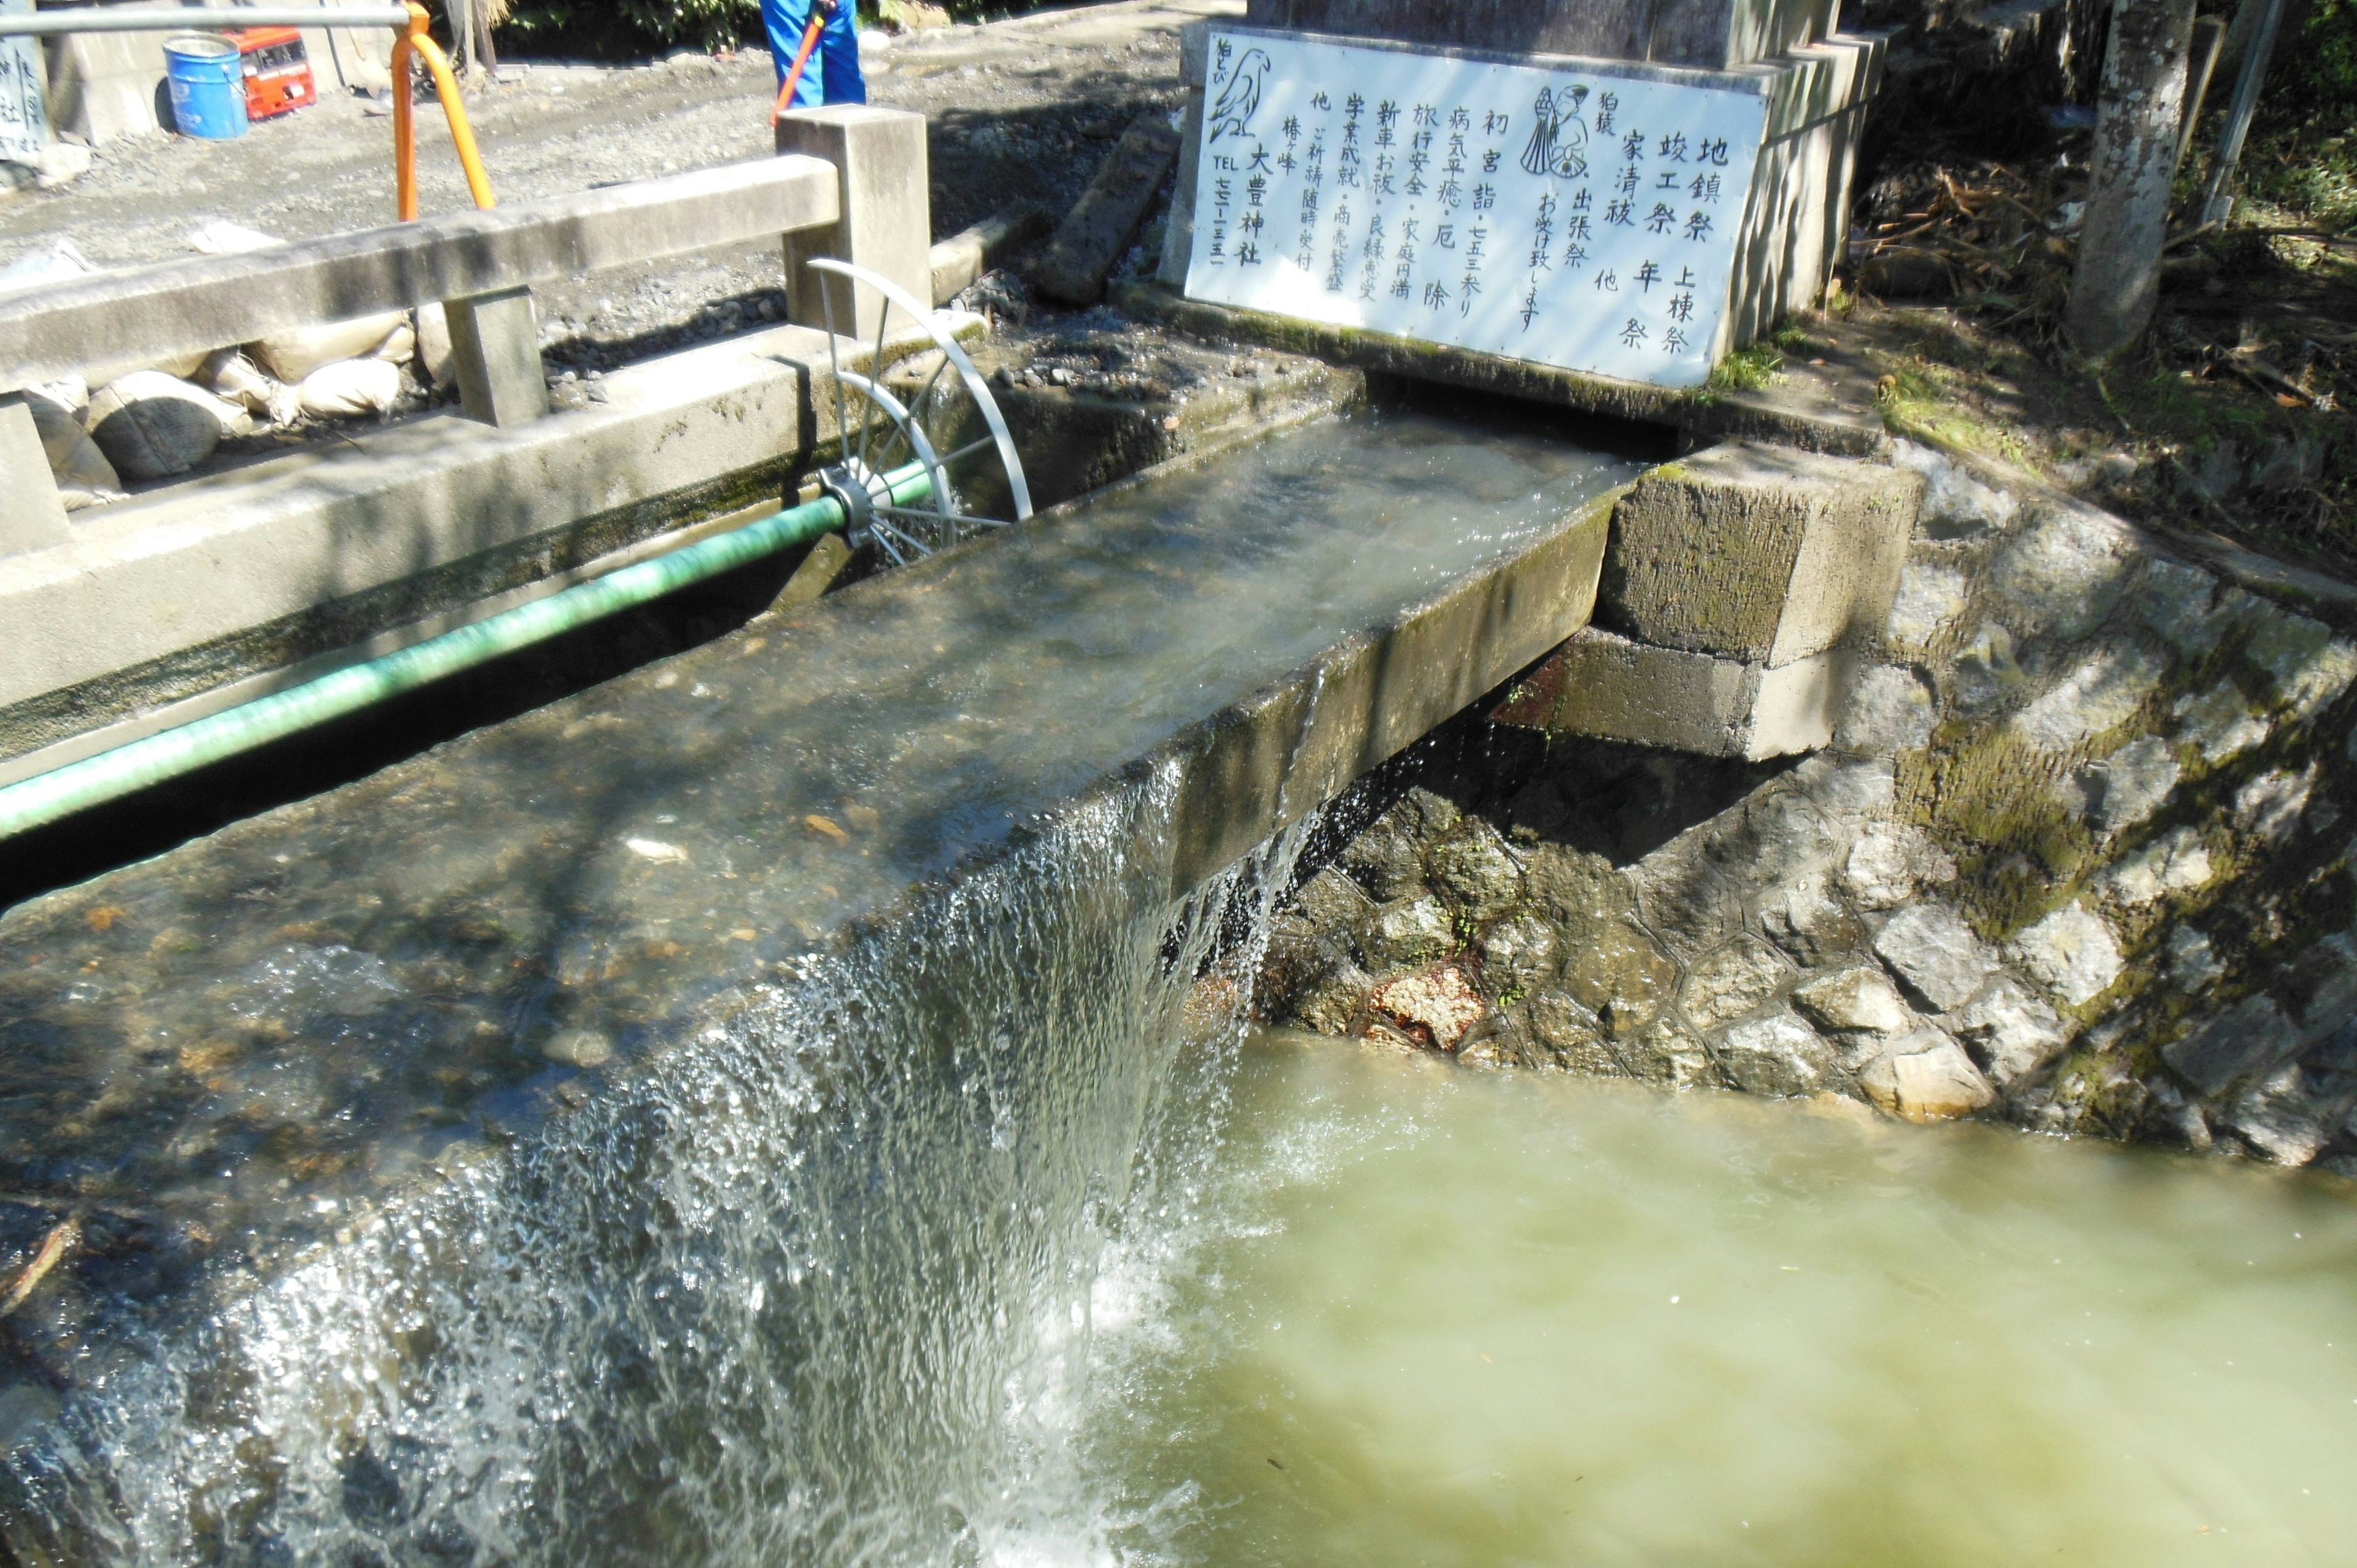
[1186, 33, 1768, 387]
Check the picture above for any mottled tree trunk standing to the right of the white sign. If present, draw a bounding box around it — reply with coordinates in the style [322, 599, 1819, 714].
[2067, 0, 2194, 363]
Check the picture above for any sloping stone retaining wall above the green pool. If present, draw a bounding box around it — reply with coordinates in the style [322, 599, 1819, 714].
[1263, 433, 2357, 1174]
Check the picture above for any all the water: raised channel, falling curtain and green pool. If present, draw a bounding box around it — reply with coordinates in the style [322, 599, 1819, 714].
[0, 398, 2357, 1568]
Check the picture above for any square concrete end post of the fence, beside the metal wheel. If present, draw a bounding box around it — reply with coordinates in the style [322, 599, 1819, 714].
[778, 104, 934, 337]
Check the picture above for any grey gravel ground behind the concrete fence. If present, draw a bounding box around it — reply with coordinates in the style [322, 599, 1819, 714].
[0, 0, 1242, 375]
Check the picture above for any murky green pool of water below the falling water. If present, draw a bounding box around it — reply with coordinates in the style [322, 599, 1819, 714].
[1028, 1038, 2357, 1568]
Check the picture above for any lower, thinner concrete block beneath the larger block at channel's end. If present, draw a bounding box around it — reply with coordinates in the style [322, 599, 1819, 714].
[1527, 627, 1855, 759]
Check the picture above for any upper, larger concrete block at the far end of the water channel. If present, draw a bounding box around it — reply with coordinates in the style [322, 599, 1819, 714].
[1598, 443, 1923, 670]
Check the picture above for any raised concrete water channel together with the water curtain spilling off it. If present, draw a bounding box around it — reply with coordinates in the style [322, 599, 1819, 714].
[0, 398, 1636, 1566]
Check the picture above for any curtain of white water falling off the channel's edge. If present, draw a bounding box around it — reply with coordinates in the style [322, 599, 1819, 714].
[14, 778, 1301, 1568]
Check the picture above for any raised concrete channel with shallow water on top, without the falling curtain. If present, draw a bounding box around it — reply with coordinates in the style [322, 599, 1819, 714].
[0, 393, 1641, 1561]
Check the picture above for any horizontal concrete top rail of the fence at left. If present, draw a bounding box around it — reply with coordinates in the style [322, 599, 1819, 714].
[0, 156, 842, 392]
